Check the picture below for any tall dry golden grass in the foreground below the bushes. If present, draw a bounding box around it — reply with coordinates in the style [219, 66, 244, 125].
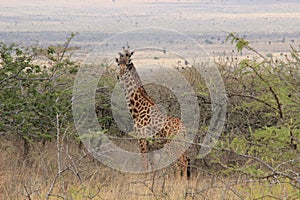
[0, 138, 300, 200]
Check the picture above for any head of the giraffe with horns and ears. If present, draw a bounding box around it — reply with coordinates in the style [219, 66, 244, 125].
[116, 46, 134, 78]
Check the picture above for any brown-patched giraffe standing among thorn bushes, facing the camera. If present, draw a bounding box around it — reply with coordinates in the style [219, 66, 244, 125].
[116, 47, 190, 179]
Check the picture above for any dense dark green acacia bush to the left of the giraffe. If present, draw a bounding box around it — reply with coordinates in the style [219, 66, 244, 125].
[0, 34, 78, 148]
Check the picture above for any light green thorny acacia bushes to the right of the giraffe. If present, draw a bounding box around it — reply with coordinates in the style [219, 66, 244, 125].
[210, 33, 300, 189]
